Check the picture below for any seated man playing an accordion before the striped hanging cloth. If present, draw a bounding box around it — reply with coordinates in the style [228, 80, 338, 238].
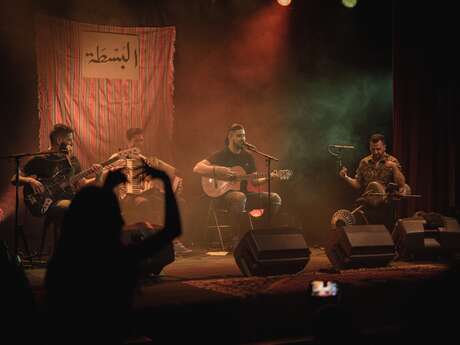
[112, 128, 191, 254]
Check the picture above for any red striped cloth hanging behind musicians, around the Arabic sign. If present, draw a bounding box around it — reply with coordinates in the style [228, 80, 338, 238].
[36, 15, 176, 167]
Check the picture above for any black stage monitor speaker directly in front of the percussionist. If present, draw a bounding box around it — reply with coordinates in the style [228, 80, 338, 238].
[326, 225, 395, 269]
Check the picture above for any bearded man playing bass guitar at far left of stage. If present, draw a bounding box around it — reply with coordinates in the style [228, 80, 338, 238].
[11, 124, 102, 224]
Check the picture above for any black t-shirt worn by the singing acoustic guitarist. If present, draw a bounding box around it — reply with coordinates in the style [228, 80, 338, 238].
[206, 146, 256, 192]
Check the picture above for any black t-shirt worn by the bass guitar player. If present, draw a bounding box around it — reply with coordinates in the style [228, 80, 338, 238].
[22, 154, 81, 179]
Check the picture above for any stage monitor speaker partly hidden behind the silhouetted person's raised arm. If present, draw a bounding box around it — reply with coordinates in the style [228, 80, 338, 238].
[122, 230, 175, 275]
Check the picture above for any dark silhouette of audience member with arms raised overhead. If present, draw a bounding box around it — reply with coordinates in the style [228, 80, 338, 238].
[45, 166, 182, 344]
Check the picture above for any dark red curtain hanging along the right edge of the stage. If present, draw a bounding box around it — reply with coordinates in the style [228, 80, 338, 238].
[393, 1, 460, 216]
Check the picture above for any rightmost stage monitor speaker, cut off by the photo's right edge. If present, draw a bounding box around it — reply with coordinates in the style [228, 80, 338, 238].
[392, 213, 460, 260]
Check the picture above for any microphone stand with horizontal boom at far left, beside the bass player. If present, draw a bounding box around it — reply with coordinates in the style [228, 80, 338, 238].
[0, 151, 61, 259]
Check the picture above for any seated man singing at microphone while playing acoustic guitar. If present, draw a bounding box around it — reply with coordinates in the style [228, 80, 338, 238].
[193, 123, 281, 238]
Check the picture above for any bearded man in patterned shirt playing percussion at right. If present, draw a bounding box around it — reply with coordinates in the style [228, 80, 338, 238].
[339, 134, 407, 231]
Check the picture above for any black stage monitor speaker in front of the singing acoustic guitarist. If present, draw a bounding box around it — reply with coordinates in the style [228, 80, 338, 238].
[233, 227, 310, 276]
